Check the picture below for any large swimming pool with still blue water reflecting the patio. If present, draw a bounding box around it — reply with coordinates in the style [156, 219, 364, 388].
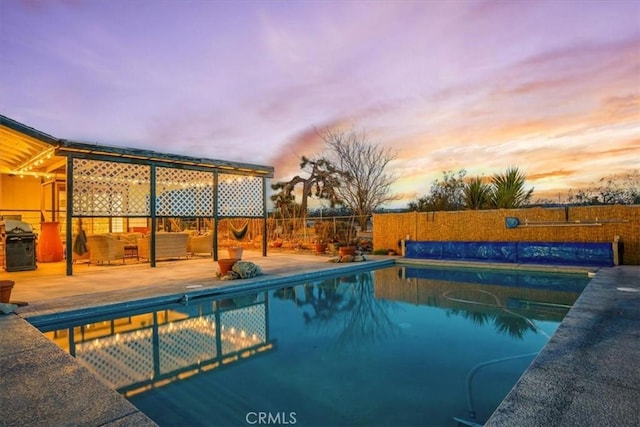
[38, 266, 589, 426]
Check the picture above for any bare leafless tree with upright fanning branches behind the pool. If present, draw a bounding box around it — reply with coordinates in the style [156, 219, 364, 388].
[318, 129, 396, 231]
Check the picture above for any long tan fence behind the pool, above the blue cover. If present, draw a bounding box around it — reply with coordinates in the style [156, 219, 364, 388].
[373, 205, 640, 265]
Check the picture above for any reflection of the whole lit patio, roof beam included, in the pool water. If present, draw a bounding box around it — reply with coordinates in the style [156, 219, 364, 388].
[45, 292, 275, 396]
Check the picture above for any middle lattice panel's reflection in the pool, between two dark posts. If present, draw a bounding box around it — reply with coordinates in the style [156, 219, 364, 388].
[158, 315, 217, 374]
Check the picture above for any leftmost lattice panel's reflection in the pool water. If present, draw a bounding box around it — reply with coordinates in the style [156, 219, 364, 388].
[76, 329, 153, 389]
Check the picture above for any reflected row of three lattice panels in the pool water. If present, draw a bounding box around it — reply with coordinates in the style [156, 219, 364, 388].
[52, 303, 267, 390]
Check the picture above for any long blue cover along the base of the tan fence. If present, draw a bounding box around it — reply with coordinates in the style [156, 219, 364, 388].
[405, 240, 613, 267]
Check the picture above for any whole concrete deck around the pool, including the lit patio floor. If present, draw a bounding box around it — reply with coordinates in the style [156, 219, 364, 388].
[0, 254, 640, 426]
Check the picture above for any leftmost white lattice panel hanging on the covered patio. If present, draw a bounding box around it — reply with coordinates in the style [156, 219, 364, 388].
[73, 158, 151, 216]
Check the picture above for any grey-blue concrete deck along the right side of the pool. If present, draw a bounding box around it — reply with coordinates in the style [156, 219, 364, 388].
[485, 266, 640, 427]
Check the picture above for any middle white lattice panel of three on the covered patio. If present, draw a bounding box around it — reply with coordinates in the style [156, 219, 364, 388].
[156, 168, 214, 217]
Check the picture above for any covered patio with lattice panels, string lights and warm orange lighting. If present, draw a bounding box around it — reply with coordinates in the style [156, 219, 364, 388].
[0, 115, 274, 275]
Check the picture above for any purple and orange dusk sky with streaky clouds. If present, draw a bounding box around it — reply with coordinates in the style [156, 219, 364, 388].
[0, 0, 640, 207]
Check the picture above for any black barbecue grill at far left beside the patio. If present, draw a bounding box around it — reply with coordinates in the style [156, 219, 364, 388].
[4, 219, 37, 271]
